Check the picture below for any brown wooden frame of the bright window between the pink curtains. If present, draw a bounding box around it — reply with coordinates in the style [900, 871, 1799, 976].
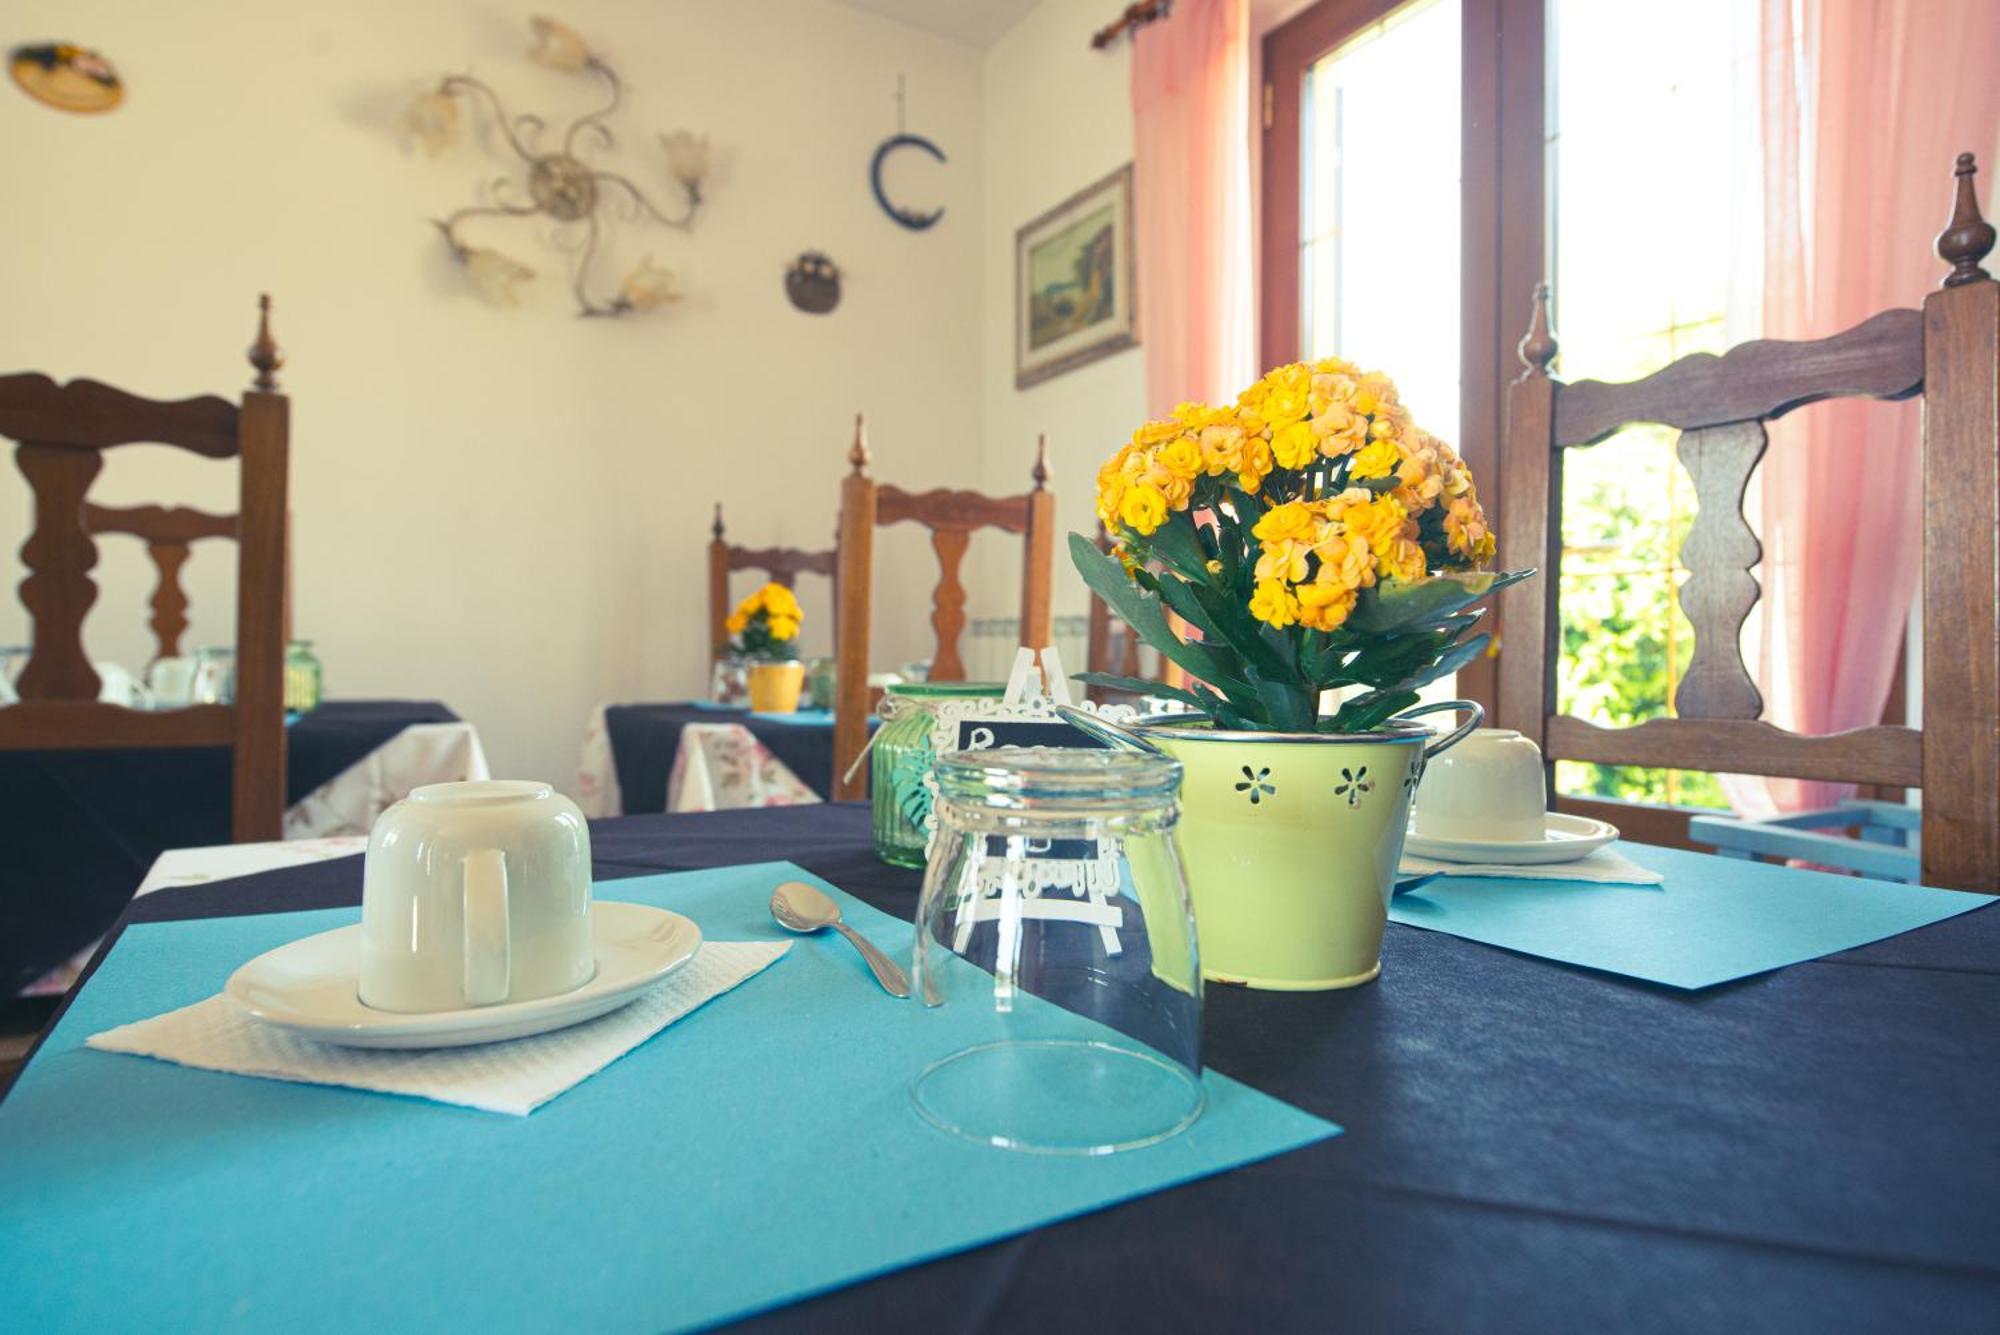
[1258, 0, 1548, 711]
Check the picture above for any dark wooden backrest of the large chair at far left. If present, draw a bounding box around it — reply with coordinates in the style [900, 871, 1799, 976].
[0, 296, 290, 841]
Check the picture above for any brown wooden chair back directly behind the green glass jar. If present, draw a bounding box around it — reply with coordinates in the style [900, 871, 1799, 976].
[834, 414, 1056, 801]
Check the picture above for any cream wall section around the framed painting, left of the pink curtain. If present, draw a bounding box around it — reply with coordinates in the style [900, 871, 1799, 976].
[972, 0, 1146, 623]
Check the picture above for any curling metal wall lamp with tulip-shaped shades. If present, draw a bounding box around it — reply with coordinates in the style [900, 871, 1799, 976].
[404, 18, 708, 316]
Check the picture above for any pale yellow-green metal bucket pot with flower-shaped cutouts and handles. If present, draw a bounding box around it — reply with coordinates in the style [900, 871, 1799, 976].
[1134, 699, 1484, 991]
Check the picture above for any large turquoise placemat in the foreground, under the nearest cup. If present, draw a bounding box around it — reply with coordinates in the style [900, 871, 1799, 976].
[0, 863, 1338, 1335]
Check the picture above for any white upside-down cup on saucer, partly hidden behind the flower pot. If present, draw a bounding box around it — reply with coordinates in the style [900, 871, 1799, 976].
[1402, 727, 1618, 867]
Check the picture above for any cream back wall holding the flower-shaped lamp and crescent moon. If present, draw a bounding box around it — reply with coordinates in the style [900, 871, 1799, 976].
[0, 0, 984, 783]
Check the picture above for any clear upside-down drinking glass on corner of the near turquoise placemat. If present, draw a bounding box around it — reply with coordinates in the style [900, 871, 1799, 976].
[910, 747, 1204, 1155]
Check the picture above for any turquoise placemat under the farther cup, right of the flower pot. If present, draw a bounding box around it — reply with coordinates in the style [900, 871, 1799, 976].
[1388, 843, 1992, 989]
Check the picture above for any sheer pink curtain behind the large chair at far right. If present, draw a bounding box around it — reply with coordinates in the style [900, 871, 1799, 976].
[1730, 0, 2000, 815]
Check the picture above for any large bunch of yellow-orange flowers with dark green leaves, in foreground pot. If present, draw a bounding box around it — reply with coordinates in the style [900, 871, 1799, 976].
[1070, 358, 1534, 733]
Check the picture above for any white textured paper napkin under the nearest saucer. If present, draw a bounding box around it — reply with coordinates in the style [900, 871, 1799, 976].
[88, 941, 792, 1117]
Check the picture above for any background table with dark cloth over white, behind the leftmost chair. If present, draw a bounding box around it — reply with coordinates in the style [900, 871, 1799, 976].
[0, 699, 486, 997]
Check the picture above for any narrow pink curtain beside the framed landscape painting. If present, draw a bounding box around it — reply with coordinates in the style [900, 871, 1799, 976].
[1132, 0, 1252, 416]
